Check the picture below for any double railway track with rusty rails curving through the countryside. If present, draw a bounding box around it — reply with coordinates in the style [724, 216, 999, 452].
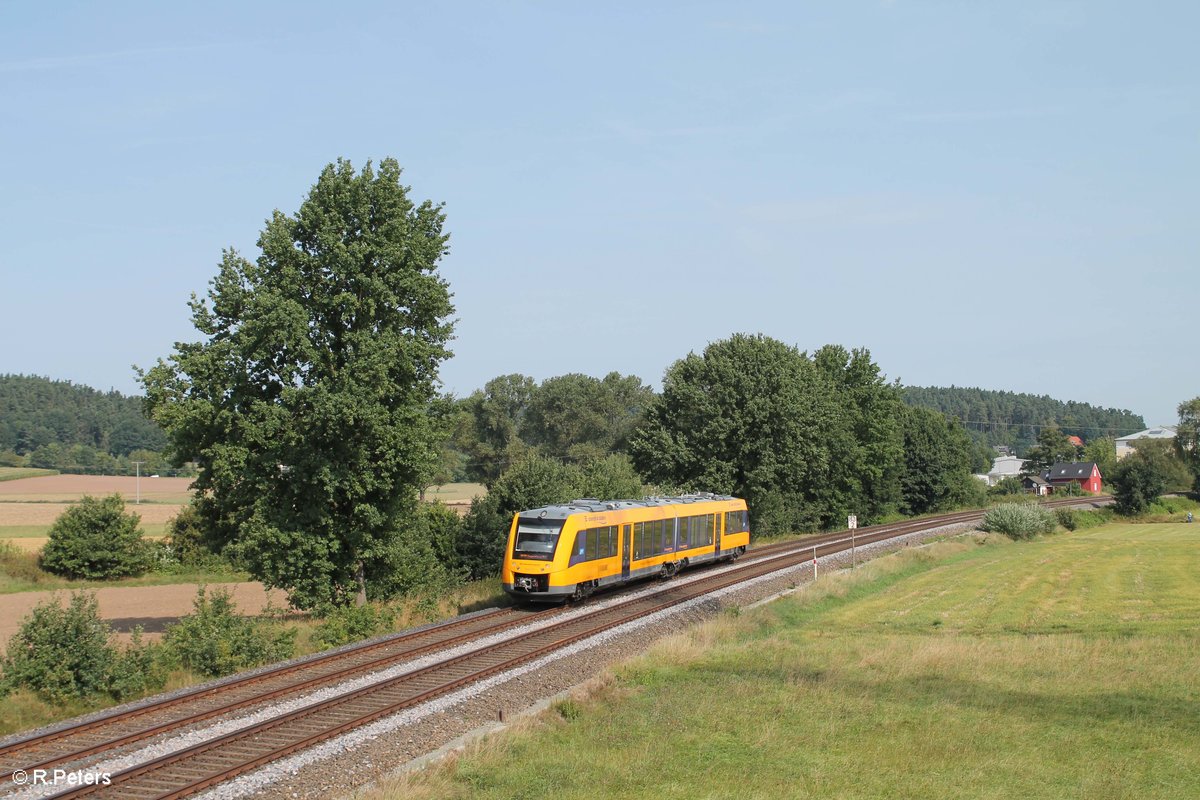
[9, 498, 1104, 800]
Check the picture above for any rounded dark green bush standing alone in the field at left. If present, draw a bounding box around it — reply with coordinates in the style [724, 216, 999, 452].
[41, 494, 149, 581]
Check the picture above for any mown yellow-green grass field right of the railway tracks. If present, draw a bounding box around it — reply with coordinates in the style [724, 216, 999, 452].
[368, 524, 1200, 800]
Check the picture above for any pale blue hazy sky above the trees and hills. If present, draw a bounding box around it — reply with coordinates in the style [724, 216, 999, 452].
[0, 0, 1200, 425]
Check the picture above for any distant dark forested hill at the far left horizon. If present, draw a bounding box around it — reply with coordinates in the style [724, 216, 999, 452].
[0, 374, 175, 474]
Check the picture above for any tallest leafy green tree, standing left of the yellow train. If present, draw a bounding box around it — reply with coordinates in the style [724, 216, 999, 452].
[140, 158, 454, 607]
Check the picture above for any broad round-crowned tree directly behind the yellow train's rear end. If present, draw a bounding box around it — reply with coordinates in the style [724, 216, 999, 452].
[629, 333, 847, 534]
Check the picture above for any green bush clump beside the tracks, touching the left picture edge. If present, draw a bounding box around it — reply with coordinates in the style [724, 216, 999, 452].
[0, 591, 166, 703]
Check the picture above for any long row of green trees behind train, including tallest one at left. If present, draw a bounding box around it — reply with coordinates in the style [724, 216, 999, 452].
[139, 160, 1185, 607]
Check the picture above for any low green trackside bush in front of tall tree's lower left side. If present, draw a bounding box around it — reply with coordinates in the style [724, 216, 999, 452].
[163, 587, 296, 678]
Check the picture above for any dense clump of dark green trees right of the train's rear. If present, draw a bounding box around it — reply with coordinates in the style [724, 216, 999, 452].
[630, 335, 982, 534]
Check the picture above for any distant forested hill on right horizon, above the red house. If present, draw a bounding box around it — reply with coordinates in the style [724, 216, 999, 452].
[904, 386, 1146, 455]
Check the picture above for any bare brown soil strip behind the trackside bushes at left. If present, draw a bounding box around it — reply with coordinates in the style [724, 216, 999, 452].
[0, 582, 287, 645]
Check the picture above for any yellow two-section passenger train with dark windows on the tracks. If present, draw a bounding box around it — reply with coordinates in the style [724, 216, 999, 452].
[500, 493, 750, 602]
